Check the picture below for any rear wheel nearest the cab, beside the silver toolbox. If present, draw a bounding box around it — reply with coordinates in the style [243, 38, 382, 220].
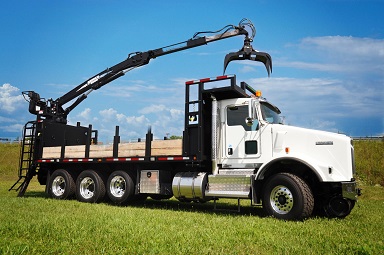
[107, 171, 135, 204]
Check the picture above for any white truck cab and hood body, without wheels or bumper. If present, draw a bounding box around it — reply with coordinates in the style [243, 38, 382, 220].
[219, 97, 354, 182]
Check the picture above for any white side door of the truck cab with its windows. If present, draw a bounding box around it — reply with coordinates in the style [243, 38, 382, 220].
[225, 104, 260, 160]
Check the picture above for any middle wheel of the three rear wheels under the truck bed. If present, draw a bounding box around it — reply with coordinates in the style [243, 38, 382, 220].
[76, 170, 105, 203]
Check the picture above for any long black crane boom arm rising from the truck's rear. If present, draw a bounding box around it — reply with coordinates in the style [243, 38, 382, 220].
[23, 19, 272, 123]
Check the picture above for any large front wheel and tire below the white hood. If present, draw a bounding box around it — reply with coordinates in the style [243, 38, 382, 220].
[263, 173, 314, 220]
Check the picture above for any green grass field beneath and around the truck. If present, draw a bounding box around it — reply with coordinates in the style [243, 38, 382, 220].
[0, 142, 384, 254]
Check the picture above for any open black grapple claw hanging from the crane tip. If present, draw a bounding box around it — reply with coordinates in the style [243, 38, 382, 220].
[223, 38, 272, 77]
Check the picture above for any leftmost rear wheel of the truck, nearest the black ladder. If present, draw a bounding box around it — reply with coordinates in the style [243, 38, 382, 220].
[48, 169, 76, 199]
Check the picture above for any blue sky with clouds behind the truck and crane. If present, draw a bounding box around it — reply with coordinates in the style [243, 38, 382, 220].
[0, 0, 384, 141]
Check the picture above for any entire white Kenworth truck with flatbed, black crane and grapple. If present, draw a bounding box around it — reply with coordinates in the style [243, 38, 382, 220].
[10, 19, 360, 220]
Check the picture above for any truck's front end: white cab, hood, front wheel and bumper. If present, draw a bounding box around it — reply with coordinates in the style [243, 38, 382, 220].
[210, 83, 358, 218]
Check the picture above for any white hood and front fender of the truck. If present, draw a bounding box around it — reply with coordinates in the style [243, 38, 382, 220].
[271, 124, 354, 182]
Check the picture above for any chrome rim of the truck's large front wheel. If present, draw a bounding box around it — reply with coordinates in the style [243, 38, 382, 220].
[269, 185, 293, 214]
